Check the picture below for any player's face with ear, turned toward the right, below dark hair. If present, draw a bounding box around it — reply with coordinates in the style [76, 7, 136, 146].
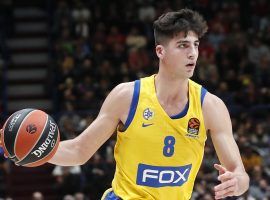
[156, 31, 199, 78]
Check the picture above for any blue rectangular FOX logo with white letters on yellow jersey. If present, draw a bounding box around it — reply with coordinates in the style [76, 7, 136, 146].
[136, 163, 192, 188]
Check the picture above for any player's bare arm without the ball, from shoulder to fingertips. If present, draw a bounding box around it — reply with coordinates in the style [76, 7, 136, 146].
[203, 92, 249, 199]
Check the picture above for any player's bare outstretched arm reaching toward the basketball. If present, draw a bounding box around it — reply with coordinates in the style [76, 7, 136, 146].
[49, 83, 134, 166]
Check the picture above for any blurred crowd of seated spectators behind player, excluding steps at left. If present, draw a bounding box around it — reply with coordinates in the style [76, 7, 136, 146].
[0, 0, 270, 200]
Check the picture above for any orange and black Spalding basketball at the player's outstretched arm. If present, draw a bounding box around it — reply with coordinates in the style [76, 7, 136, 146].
[1, 108, 60, 167]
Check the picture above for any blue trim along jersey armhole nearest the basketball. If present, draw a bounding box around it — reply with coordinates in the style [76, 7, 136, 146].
[124, 80, 141, 130]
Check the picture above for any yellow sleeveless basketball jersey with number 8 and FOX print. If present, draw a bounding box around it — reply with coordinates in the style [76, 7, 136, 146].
[112, 76, 206, 200]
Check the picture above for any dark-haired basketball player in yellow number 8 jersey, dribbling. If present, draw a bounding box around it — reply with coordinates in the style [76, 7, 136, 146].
[0, 9, 249, 200]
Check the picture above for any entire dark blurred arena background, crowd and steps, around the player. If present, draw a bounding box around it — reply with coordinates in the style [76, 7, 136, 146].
[0, 0, 270, 200]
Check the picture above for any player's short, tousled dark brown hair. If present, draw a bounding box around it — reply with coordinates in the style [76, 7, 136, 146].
[153, 8, 208, 45]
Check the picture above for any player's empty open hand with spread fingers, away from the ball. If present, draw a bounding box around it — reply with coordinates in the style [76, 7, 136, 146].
[214, 164, 239, 199]
